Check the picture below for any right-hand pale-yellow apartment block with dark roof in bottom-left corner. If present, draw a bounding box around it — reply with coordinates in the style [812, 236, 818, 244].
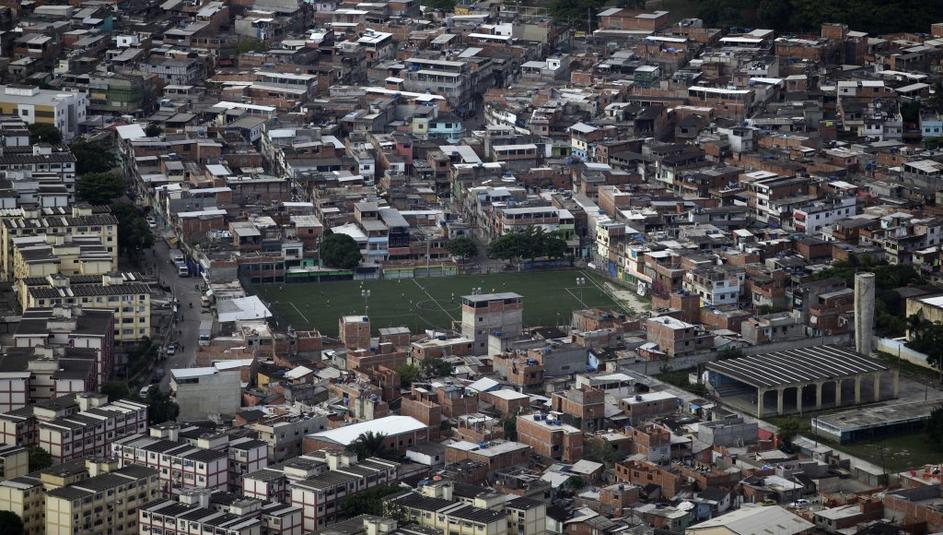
[45, 465, 159, 535]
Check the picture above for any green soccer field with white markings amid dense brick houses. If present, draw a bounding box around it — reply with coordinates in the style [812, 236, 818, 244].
[253, 269, 617, 336]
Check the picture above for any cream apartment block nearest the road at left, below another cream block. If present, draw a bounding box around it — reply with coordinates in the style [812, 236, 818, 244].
[17, 273, 151, 342]
